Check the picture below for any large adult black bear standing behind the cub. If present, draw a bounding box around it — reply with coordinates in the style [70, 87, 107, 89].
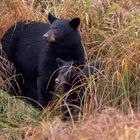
[1, 13, 85, 107]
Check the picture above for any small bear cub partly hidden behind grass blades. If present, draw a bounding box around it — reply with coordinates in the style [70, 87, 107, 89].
[55, 58, 104, 119]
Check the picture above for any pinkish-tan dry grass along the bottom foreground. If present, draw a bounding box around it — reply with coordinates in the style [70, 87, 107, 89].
[22, 108, 140, 140]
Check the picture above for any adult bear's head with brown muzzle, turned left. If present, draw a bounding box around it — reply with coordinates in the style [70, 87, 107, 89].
[43, 13, 81, 46]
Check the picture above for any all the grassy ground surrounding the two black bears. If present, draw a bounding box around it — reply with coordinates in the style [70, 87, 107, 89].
[0, 0, 140, 140]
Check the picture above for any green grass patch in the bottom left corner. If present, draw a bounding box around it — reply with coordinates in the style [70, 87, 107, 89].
[0, 91, 42, 139]
